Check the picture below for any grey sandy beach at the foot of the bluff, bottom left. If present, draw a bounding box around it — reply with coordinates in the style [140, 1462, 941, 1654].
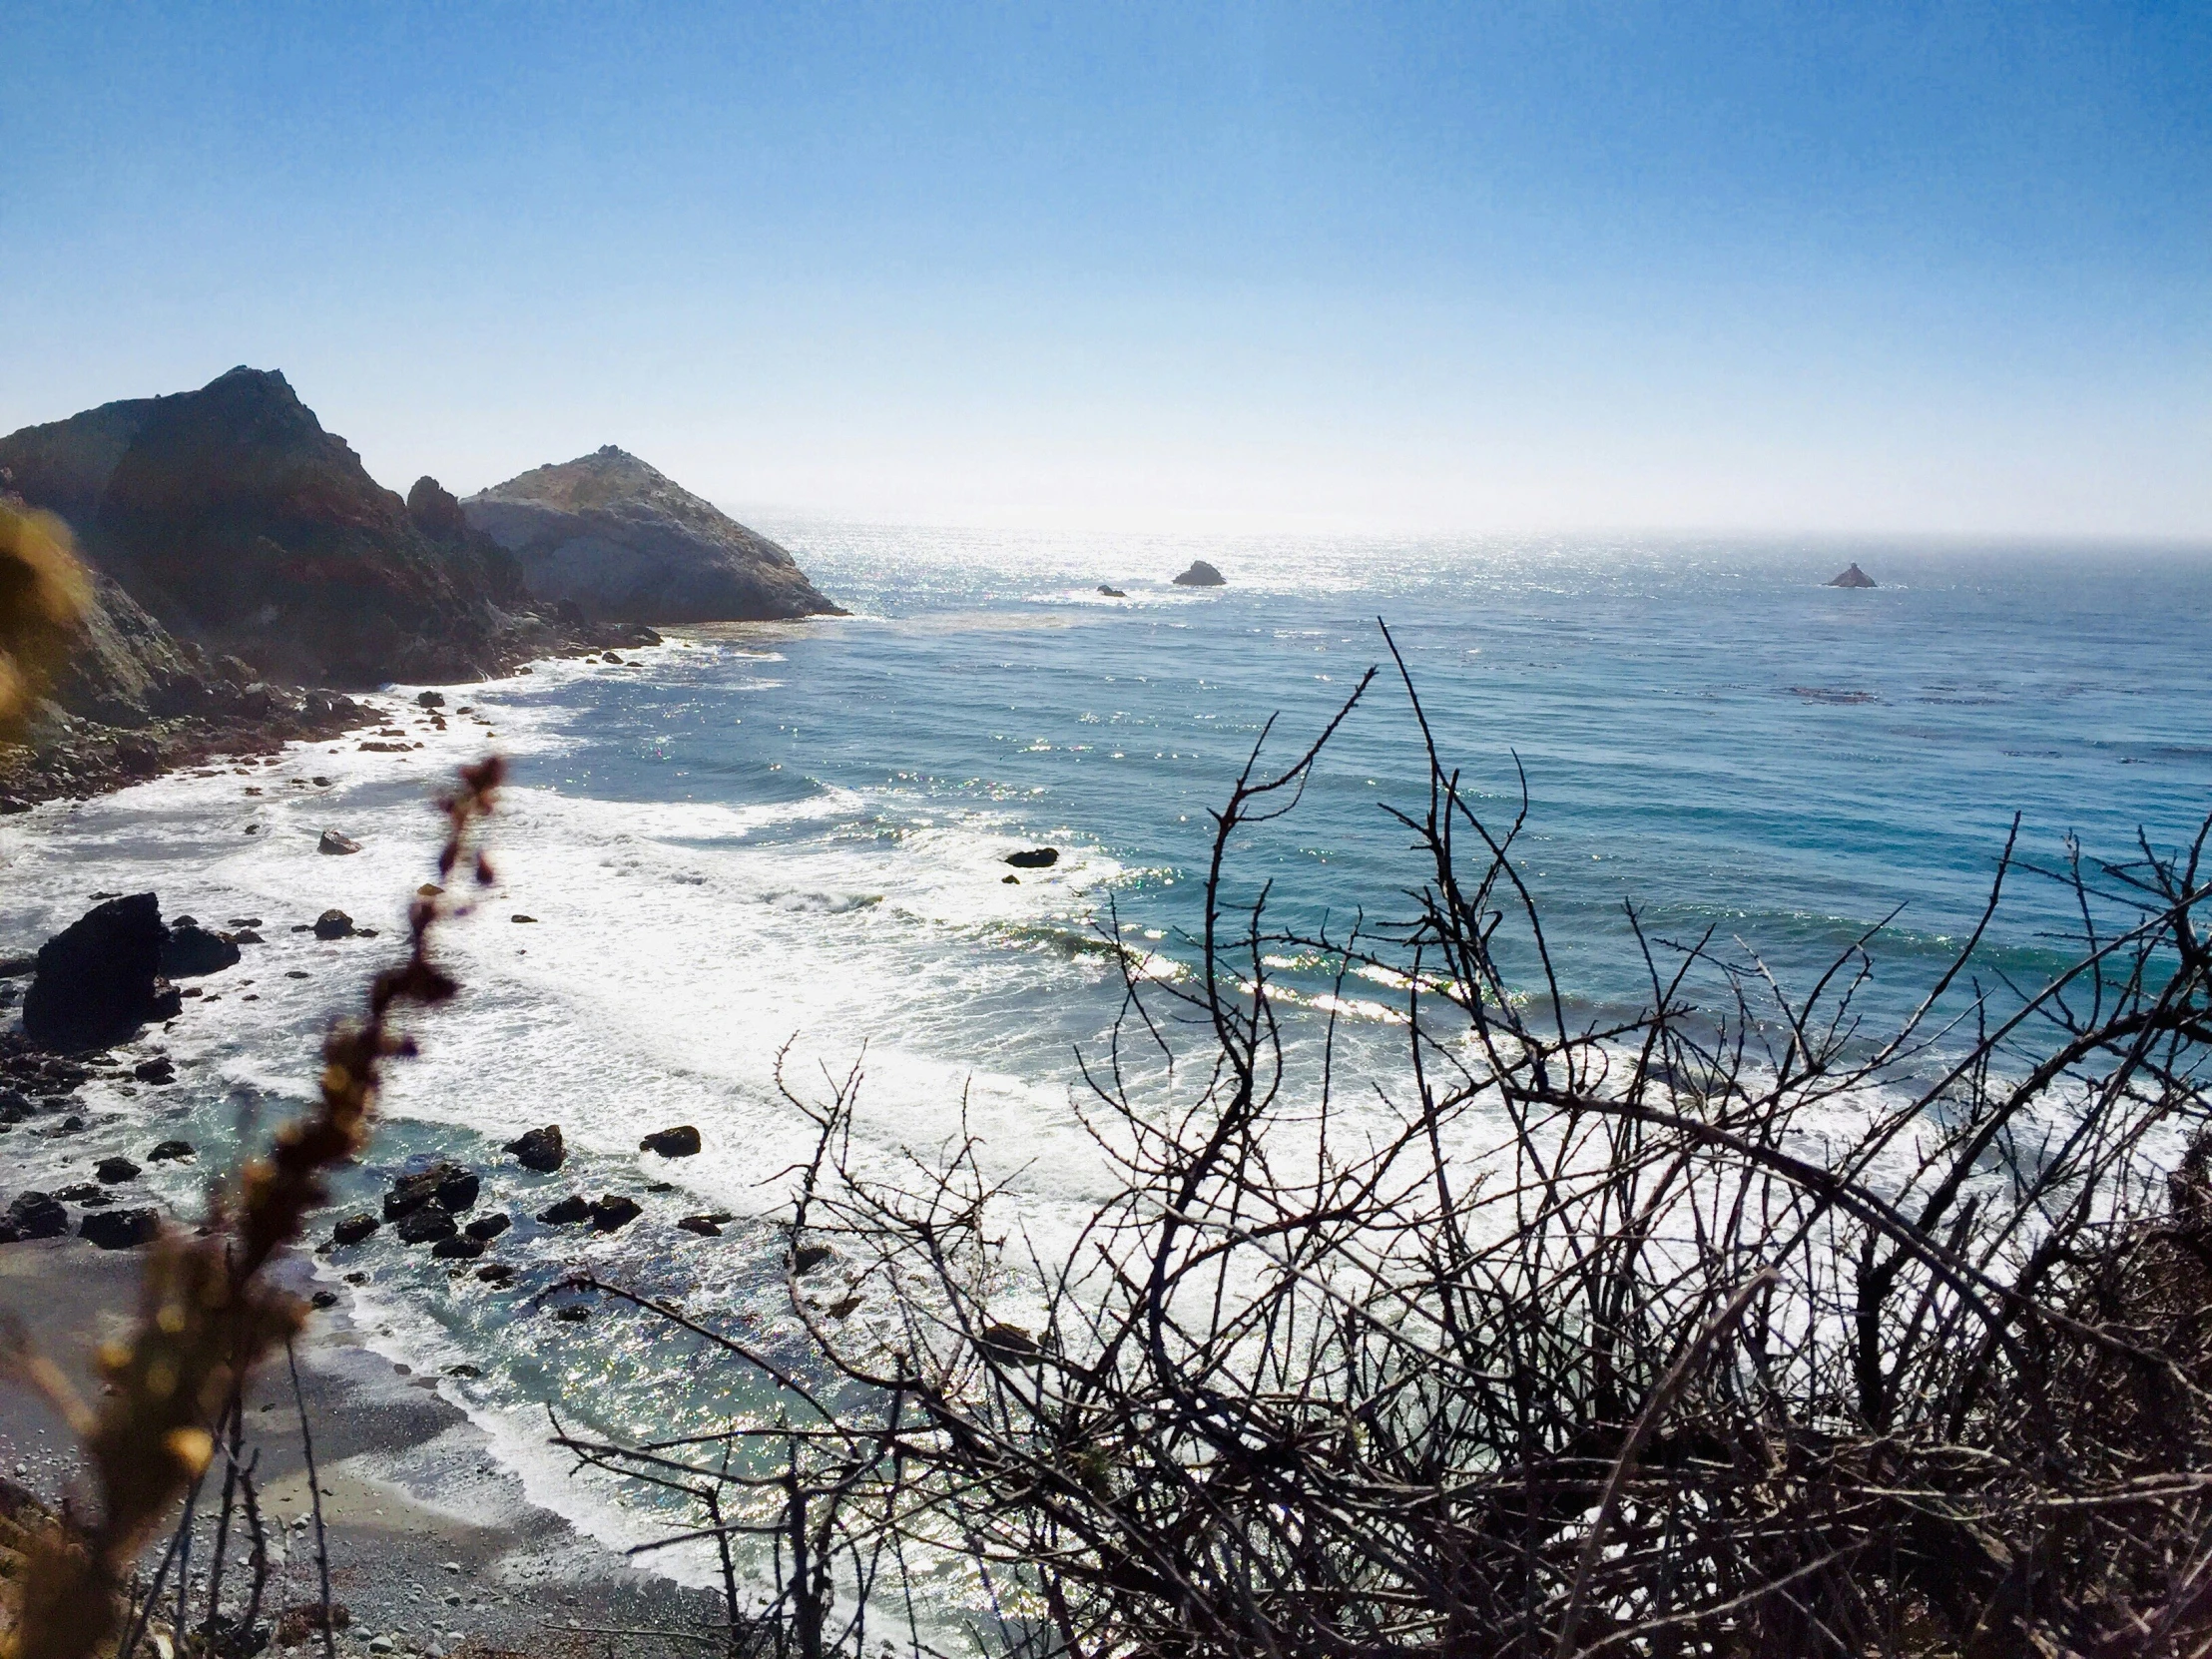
[0, 1239, 724, 1655]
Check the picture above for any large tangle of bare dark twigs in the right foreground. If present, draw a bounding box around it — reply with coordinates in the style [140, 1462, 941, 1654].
[569, 637, 2212, 1659]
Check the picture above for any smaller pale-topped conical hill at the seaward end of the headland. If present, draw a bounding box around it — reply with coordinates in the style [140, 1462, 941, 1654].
[462, 444, 842, 624]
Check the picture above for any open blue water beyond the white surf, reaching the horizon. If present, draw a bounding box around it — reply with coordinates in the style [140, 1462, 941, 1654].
[560, 529, 2212, 1026]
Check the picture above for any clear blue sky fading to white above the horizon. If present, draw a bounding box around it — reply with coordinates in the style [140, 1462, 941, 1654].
[0, 0, 2212, 537]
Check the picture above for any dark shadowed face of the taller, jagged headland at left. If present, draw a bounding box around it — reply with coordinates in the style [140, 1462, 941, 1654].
[0, 367, 544, 686]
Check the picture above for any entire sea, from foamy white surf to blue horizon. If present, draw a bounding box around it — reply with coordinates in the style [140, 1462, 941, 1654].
[0, 524, 2212, 1601]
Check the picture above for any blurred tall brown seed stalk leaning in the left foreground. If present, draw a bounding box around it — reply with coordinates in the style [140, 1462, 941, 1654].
[11, 757, 504, 1659]
